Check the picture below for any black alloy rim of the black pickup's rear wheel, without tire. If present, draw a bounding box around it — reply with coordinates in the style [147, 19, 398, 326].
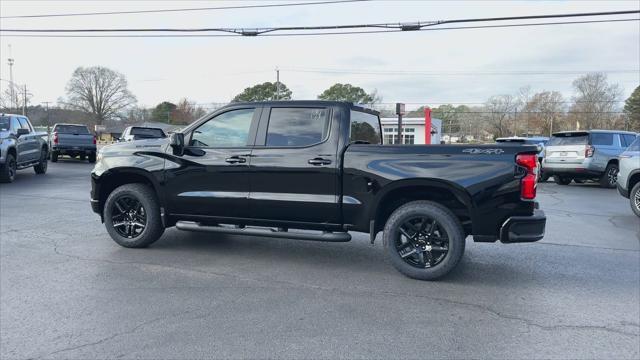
[395, 216, 449, 269]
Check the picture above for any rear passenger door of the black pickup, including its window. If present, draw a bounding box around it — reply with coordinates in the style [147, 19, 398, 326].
[249, 105, 340, 226]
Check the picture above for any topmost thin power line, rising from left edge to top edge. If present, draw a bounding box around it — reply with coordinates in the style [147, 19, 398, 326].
[0, 0, 371, 19]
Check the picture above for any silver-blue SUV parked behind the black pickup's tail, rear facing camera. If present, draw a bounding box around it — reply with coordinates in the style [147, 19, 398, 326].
[542, 130, 636, 188]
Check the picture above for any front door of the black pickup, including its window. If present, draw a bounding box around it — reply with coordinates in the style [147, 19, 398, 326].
[165, 106, 262, 220]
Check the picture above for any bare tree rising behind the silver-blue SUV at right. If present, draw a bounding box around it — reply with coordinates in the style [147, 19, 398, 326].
[570, 73, 622, 129]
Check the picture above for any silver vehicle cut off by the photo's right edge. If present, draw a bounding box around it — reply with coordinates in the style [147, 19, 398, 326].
[618, 136, 640, 217]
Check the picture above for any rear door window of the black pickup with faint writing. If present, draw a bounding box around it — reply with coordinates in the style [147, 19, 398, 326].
[267, 108, 329, 146]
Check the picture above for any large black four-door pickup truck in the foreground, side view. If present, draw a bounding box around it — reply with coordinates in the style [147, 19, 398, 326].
[91, 101, 546, 280]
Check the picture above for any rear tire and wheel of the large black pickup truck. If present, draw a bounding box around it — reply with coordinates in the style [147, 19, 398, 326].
[383, 200, 465, 280]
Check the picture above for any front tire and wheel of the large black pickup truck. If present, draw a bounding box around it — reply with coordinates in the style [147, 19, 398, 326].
[103, 184, 164, 248]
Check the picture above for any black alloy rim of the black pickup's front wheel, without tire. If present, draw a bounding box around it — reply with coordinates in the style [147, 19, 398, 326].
[111, 195, 147, 239]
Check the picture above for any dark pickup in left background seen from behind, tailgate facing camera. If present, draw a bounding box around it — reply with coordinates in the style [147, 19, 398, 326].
[49, 124, 96, 163]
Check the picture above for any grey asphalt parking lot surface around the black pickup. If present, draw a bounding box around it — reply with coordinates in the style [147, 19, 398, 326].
[0, 161, 640, 359]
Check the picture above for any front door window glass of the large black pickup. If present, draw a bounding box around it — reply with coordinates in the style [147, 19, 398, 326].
[189, 109, 255, 147]
